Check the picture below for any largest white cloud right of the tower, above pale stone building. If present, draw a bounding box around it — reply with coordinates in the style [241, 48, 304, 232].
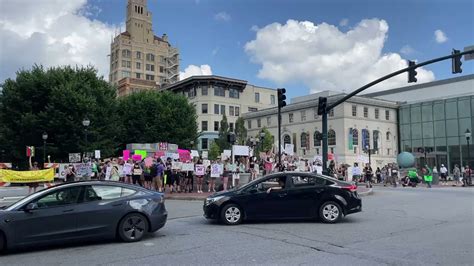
[245, 19, 434, 92]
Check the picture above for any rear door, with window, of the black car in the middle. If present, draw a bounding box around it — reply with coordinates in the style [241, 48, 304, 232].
[286, 173, 324, 218]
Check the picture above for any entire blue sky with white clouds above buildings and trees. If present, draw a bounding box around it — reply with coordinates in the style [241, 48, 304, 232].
[0, 0, 474, 98]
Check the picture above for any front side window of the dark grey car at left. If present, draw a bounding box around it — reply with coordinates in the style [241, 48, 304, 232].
[36, 186, 82, 209]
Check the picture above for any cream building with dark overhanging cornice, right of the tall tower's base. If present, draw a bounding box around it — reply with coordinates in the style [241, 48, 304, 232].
[162, 76, 277, 150]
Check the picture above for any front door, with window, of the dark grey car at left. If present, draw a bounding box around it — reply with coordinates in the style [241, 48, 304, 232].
[9, 186, 83, 244]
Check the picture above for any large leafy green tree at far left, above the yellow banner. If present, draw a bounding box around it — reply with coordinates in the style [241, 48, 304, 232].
[0, 65, 120, 166]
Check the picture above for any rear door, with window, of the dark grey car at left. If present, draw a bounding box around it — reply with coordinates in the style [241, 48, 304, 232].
[73, 185, 137, 237]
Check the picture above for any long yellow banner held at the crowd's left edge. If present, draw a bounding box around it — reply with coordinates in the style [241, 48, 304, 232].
[0, 168, 54, 183]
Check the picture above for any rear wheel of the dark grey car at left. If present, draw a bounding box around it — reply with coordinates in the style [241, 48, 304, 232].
[118, 213, 148, 242]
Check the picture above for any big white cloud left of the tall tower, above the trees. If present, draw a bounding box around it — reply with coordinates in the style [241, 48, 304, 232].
[0, 0, 115, 80]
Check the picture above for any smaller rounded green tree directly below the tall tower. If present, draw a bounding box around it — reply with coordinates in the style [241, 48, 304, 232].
[118, 91, 198, 148]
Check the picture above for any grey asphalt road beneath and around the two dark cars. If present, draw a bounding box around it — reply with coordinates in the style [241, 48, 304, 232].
[0, 187, 474, 265]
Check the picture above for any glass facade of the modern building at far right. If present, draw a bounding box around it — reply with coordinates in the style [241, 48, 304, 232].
[399, 95, 474, 173]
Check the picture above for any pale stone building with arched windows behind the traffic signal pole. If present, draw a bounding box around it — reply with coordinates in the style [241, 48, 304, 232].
[243, 91, 398, 167]
